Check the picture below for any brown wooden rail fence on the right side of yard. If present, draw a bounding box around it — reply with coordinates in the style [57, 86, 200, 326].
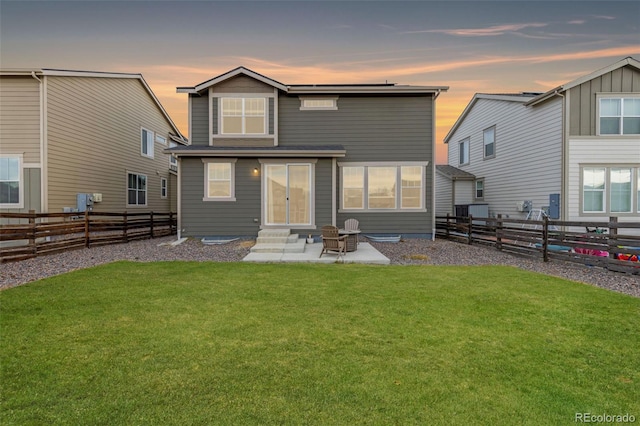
[436, 215, 640, 274]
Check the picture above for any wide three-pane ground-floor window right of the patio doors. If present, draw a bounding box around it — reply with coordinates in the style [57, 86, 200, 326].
[340, 163, 426, 211]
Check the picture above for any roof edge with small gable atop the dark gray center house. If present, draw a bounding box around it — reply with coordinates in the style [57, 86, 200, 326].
[176, 67, 449, 95]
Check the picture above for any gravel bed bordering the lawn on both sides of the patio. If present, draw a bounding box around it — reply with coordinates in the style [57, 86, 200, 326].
[0, 236, 640, 297]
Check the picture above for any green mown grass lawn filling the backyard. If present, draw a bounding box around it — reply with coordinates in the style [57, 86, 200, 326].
[0, 262, 640, 425]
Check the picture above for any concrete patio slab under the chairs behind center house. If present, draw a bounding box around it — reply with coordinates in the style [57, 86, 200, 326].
[242, 242, 391, 265]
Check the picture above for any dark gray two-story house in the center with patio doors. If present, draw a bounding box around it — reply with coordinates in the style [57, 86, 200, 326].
[168, 67, 448, 236]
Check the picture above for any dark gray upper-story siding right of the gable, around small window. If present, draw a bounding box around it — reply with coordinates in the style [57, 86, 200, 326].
[278, 95, 433, 161]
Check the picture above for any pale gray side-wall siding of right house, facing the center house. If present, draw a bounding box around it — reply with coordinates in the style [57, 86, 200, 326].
[448, 99, 562, 218]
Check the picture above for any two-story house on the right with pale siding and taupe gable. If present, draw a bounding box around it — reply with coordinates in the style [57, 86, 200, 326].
[438, 57, 640, 230]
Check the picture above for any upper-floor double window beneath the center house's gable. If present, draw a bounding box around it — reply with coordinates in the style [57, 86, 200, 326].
[220, 98, 267, 135]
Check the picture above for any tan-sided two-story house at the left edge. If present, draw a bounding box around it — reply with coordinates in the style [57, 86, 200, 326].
[0, 69, 186, 213]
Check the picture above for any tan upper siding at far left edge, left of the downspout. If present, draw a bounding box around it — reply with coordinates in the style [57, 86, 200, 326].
[0, 76, 40, 164]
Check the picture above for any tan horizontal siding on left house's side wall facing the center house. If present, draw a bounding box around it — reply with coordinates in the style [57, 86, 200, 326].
[46, 76, 175, 212]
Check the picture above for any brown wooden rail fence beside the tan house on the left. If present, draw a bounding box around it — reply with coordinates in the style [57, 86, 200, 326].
[0, 210, 177, 262]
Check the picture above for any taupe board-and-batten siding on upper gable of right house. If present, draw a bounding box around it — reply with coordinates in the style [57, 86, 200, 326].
[568, 66, 640, 136]
